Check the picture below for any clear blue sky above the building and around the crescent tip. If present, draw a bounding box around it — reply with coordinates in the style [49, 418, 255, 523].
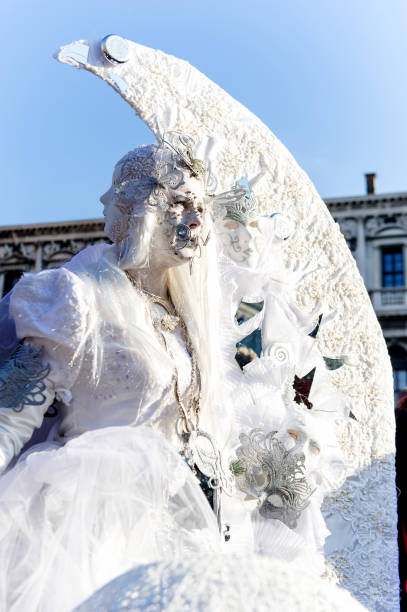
[0, 0, 407, 225]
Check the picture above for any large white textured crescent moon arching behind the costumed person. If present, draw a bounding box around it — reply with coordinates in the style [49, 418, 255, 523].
[56, 39, 398, 610]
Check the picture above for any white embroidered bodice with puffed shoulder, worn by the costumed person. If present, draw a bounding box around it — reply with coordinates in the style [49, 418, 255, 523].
[10, 246, 191, 447]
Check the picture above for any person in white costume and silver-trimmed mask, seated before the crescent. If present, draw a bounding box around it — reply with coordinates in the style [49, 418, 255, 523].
[0, 139, 228, 610]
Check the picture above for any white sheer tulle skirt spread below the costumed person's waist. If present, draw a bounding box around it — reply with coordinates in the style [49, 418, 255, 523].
[0, 427, 222, 612]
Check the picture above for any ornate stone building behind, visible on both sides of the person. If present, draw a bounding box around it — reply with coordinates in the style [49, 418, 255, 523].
[0, 174, 407, 393]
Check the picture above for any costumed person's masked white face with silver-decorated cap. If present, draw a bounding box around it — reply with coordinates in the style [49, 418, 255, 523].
[100, 133, 208, 265]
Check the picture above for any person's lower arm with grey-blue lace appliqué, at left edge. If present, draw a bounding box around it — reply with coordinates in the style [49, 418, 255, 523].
[0, 343, 55, 473]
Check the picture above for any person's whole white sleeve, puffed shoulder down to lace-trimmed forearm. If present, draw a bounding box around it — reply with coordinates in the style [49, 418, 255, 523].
[0, 268, 87, 472]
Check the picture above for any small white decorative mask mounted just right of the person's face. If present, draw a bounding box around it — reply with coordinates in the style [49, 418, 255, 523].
[217, 217, 264, 268]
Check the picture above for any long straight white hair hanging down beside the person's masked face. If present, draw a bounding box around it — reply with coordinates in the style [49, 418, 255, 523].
[114, 145, 227, 440]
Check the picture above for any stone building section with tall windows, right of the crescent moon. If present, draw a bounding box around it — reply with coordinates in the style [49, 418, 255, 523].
[325, 174, 407, 396]
